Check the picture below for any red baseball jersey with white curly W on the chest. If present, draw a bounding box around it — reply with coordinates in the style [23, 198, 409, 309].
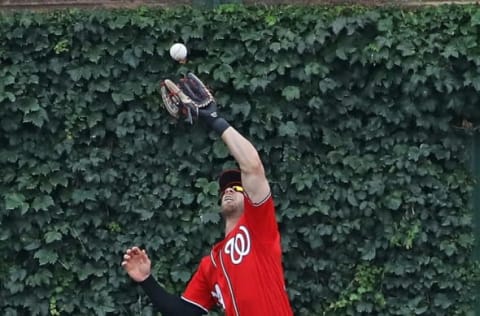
[182, 195, 293, 316]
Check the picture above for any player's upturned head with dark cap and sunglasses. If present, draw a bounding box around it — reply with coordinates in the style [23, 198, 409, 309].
[218, 169, 244, 216]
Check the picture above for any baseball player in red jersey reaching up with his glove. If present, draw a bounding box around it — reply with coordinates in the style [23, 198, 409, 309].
[122, 73, 293, 316]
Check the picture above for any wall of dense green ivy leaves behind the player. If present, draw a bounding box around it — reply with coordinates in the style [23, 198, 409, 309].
[0, 5, 480, 316]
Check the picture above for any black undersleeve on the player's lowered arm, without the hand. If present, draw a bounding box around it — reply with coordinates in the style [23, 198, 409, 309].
[139, 275, 207, 316]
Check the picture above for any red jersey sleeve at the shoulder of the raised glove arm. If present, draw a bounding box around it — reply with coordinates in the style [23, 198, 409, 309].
[244, 194, 280, 242]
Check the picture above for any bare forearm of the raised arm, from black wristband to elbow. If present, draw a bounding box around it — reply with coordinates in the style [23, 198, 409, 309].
[222, 127, 264, 174]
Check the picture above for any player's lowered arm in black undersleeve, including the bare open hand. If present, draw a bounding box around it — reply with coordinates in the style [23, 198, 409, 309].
[122, 247, 205, 316]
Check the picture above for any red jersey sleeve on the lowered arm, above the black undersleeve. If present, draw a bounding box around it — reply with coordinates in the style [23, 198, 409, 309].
[182, 257, 215, 312]
